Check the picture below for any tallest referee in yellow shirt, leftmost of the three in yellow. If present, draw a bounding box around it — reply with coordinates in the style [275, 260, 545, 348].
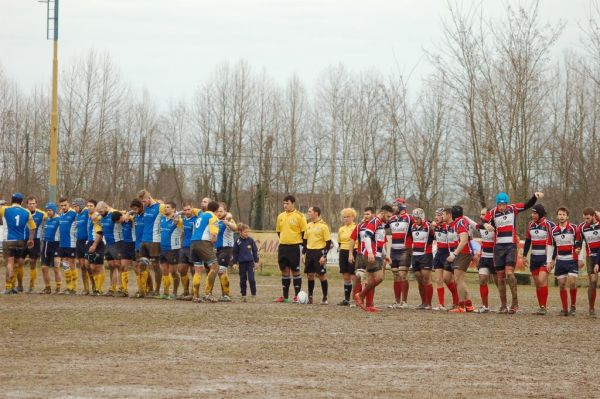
[275, 195, 306, 303]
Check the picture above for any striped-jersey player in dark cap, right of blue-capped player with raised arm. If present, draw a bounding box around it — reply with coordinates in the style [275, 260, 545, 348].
[523, 204, 555, 315]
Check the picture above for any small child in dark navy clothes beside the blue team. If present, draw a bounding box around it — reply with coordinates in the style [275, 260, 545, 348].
[233, 223, 259, 302]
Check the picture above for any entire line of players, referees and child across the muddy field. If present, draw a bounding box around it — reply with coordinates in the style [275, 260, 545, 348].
[0, 190, 600, 316]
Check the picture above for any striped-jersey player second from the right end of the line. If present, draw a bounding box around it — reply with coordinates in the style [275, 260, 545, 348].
[549, 207, 581, 316]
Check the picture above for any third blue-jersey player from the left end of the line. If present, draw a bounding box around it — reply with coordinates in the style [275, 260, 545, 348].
[40, 202, 62, 294]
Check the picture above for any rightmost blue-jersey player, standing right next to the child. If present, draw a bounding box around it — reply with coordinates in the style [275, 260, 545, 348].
[206, 202, 237, 302]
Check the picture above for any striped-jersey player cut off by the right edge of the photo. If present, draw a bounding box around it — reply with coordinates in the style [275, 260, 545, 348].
[579, 208, 600, 317]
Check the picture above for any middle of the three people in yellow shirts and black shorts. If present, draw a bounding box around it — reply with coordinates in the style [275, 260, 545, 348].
[302, 206, 331, 305]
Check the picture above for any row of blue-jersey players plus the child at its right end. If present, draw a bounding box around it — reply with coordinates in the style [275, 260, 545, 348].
[0, 190, 259, 302]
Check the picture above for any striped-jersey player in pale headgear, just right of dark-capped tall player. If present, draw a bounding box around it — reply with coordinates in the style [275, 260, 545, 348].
[410, 208, 434, 310]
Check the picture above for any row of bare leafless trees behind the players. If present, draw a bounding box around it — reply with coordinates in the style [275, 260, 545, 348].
[0, 4, 600, 229]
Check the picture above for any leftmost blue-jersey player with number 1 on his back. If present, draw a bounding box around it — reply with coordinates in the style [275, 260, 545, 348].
[0, 193, 36, 294]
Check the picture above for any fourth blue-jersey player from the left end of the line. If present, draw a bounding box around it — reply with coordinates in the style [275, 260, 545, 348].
[58, 197, 78, 295]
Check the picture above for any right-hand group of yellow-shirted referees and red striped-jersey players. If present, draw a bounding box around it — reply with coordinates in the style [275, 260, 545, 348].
[276, 192, 600, 316]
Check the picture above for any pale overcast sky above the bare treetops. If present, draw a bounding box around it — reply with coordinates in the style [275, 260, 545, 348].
[0, 0, 590, 104]
